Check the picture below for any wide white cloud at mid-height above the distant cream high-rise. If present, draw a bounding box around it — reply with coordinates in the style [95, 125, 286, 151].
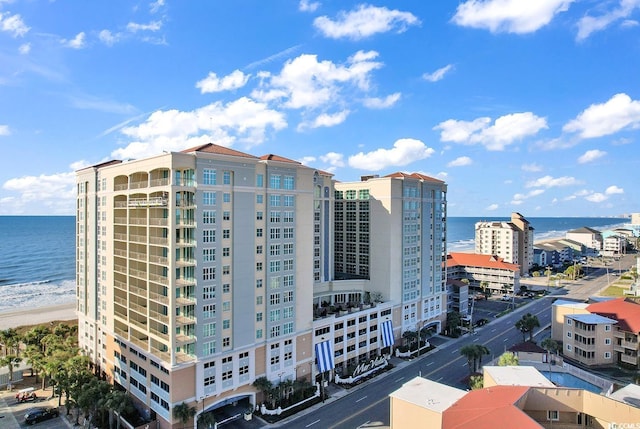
[433, 112, 548, 151]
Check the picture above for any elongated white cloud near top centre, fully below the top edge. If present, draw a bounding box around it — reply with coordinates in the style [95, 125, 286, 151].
[313, 5, 420, 40]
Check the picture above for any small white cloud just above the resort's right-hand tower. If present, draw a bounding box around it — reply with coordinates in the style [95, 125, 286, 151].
[349, 139, 435, 171]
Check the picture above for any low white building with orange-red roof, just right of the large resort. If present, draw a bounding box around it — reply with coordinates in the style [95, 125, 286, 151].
[447, 252, 520, 293]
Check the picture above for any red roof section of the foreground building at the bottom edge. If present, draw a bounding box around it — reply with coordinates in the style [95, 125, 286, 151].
[442, 386, 542, 429]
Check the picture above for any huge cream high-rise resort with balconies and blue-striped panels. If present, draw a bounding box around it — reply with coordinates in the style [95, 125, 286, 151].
[76, 144, 447, 428]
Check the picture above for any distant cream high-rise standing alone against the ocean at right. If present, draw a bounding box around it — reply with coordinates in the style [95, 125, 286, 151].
[475, 212, 533, 275]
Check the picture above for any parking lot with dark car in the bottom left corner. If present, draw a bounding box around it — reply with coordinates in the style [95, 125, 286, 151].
[0, 377, 72, 429]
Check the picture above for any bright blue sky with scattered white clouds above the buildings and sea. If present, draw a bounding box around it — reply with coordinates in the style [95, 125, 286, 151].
[0, 0, 640, 214]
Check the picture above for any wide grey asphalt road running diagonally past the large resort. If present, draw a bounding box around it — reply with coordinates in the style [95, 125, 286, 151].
[274, 251, 635, 429]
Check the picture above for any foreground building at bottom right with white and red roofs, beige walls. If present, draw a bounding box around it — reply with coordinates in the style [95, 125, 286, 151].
[389, 367, 640, 429]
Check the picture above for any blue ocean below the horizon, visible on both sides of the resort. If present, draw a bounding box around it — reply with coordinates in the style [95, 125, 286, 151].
[0, 216, 629, 312]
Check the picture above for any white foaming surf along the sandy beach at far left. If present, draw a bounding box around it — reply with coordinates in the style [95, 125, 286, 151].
[0, 280, 76, 312]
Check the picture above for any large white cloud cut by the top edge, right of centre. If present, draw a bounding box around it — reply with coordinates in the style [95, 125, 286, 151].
[452, 0, 574, 34]
